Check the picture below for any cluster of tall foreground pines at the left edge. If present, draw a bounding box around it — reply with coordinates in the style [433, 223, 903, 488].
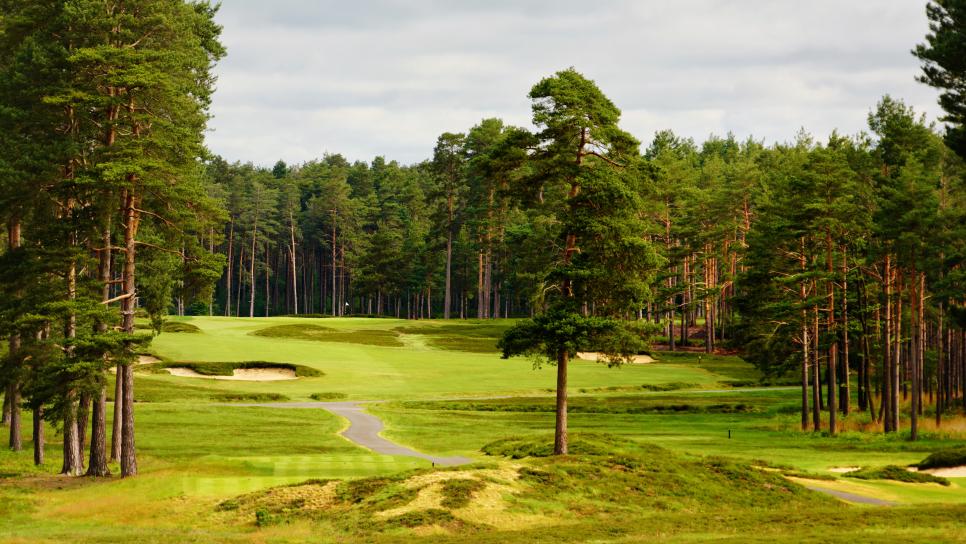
[0, 0, 224, 476]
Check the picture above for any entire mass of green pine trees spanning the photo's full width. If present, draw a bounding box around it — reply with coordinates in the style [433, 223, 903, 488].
[0, 1, 966, 475]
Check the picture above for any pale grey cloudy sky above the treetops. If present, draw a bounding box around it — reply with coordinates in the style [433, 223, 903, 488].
[208, 0, 940, 165]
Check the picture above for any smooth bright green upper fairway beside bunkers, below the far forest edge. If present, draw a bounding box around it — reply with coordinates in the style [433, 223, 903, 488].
[144, 318, 717, 400]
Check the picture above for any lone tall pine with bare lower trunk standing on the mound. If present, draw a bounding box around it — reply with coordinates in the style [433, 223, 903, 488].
[500, 69, 660, 455]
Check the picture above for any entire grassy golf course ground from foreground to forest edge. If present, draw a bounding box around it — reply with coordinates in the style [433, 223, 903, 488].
[0, 317, 966, 542]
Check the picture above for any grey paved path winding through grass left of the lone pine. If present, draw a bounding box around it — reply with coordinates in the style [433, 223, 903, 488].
[250, 401, 473, 466]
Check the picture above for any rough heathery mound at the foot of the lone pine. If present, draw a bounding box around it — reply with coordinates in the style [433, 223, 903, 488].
[219, 435, 834, 542]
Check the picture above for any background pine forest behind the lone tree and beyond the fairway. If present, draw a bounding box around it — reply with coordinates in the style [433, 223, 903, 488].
[200, 93, 966, 446]
